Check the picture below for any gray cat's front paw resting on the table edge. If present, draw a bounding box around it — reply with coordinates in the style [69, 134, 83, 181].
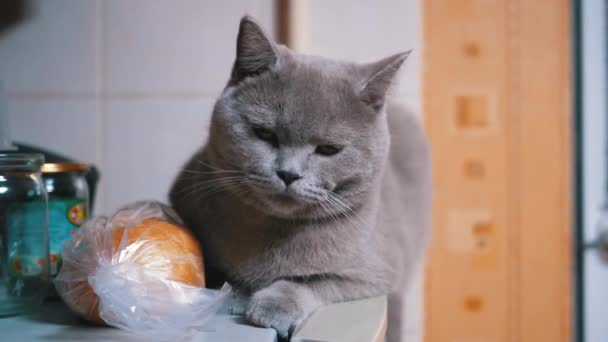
[246, 288, 305, 338]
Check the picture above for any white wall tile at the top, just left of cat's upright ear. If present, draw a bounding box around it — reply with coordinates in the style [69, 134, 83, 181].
[103, 0, 271, 96]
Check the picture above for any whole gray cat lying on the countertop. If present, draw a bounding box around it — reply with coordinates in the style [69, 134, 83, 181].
[170, 17, 430, 341]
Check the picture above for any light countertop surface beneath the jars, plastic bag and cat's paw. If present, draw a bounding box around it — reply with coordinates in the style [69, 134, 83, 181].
[0, 297, 394, 342]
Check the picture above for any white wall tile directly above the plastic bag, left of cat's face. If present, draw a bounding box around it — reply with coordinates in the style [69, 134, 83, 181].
[103, 99, 213, 213]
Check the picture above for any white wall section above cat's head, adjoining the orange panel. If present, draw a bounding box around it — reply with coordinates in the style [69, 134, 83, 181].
[308, 0, 422, 108]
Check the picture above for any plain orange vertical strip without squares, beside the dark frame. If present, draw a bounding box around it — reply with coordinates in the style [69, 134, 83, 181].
[514, 0, 574, 341]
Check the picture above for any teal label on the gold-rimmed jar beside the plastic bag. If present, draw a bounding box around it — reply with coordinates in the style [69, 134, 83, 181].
[49, 199, 89, 276]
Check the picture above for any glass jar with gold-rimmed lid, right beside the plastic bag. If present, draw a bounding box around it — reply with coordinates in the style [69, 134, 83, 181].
[42, 163, 89, 278]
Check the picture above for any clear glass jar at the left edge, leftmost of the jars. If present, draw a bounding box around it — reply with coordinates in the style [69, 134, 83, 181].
[0, 153, 49, 316]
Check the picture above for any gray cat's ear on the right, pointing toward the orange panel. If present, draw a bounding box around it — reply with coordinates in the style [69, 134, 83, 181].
[359, 50, 412, 111]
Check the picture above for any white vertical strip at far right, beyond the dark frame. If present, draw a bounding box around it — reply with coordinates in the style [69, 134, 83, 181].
[582, 0, 608, 342]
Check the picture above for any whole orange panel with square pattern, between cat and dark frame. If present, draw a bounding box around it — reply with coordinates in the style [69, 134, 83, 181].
[423, 0, 572, 342]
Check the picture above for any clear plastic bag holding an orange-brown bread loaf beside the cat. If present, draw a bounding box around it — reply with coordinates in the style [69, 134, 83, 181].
[55, 202, 230, 339]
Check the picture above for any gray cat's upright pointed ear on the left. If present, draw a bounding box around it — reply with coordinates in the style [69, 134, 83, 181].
[230, 16, 278, 84]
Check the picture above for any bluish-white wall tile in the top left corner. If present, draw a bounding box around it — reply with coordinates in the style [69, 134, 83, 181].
[0, 0, 96, 95]
